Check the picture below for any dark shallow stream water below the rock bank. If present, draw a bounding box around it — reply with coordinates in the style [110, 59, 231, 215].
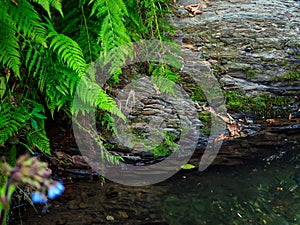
[10, 150, 300, 225]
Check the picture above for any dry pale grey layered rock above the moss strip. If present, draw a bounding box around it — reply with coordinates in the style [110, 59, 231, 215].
[171, 0, 300, 107]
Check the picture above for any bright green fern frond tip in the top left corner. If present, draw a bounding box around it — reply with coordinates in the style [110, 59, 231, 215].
[0, 0, 47, 78]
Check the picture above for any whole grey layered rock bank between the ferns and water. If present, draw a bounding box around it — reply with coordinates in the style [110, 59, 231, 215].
[50, 0, 300, 171]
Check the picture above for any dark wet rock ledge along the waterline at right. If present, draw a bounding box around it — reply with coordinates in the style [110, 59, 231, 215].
[190, 119, 300, 165]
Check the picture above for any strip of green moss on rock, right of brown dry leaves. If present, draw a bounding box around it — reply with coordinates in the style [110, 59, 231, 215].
[226, 91, 292, 118]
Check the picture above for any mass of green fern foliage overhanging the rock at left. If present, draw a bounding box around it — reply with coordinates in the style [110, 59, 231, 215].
[0, 0, 178, 163]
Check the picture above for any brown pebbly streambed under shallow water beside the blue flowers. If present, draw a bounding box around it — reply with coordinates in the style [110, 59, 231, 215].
[10, 181, 167, 225]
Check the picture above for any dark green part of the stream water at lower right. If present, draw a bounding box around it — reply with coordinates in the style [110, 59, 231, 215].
[162, 155, 300, 225]
